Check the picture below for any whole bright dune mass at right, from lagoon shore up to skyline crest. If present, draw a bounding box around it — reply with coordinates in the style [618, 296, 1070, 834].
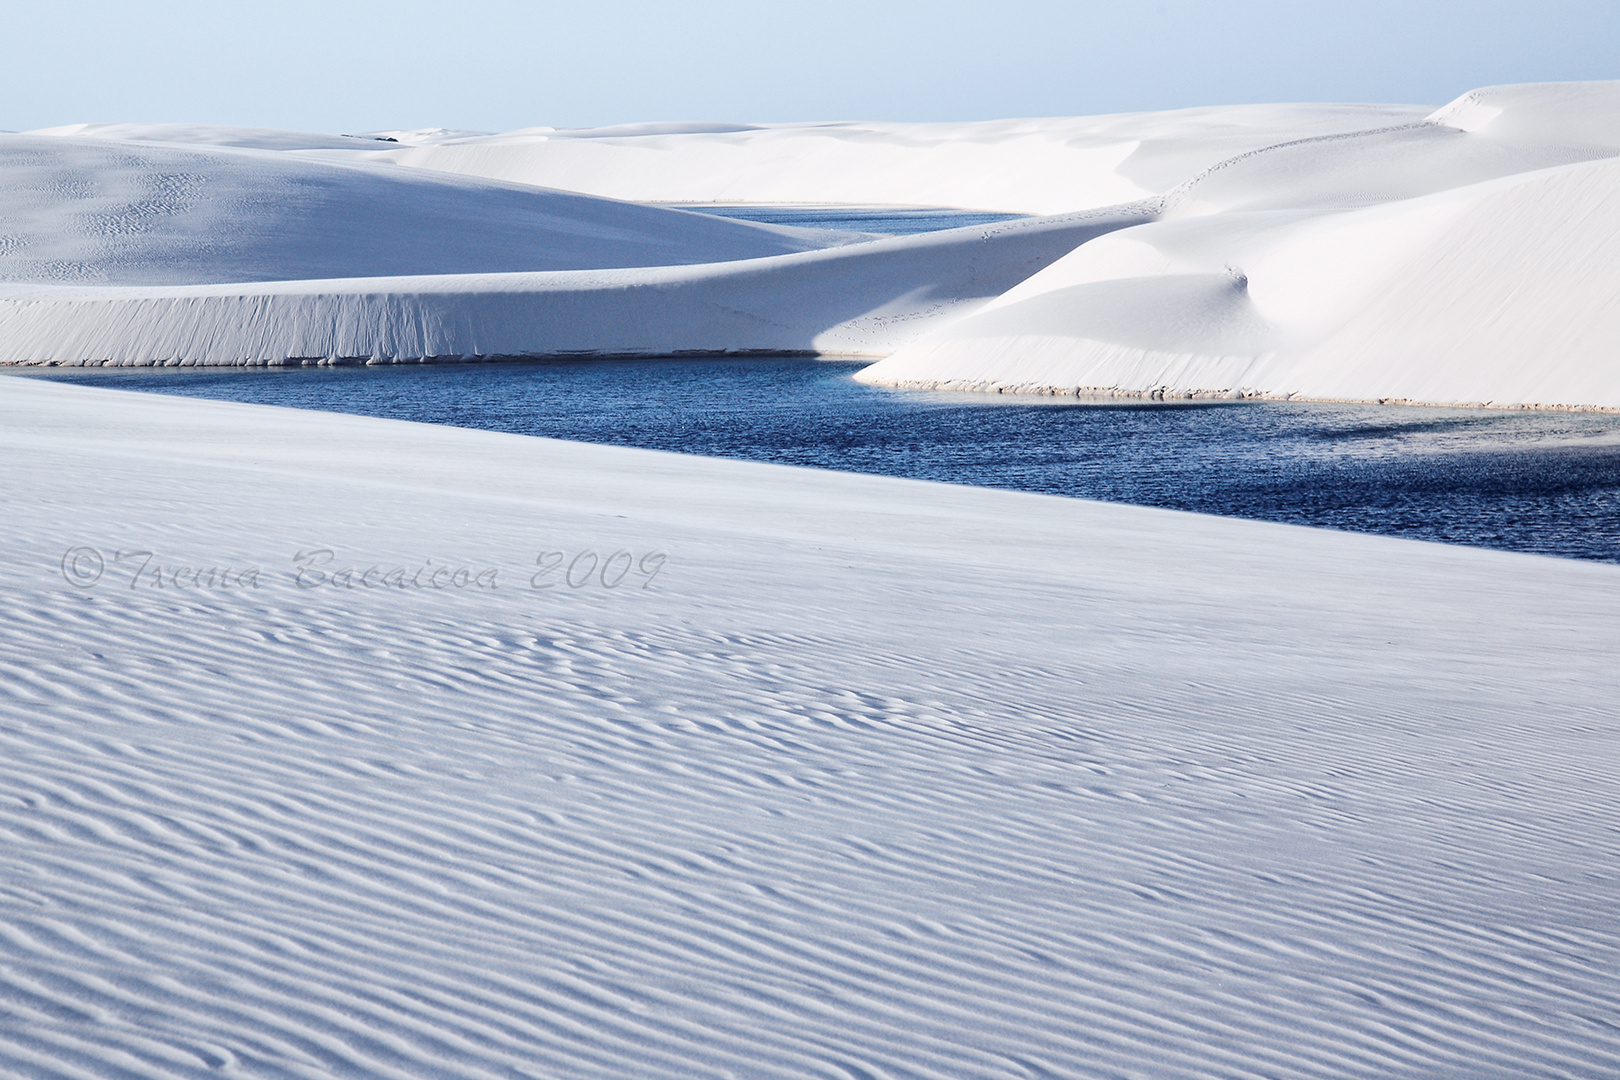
[862, 83, 1620, 408]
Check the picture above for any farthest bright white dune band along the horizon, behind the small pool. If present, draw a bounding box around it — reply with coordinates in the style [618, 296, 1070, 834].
[41, 105, 1429, 214]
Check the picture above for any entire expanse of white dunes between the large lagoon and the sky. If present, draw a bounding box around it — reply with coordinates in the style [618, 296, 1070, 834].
[0, 83, 1620, 408]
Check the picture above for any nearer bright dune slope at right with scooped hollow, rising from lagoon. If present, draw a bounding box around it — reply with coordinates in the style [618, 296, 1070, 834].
[857, 153, 1620, 410]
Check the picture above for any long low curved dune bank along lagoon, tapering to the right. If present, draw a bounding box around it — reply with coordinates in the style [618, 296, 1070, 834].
[0, 207, 1150, 366]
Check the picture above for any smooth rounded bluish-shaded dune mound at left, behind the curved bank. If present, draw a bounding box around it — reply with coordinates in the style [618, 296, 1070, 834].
[0, 134, 847, 285]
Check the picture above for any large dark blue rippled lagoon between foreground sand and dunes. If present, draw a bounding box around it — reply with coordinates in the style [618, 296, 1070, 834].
[22, 358, 1620, 562]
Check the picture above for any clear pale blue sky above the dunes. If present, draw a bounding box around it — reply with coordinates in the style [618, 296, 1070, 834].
[0, 0, 1620, 131]
